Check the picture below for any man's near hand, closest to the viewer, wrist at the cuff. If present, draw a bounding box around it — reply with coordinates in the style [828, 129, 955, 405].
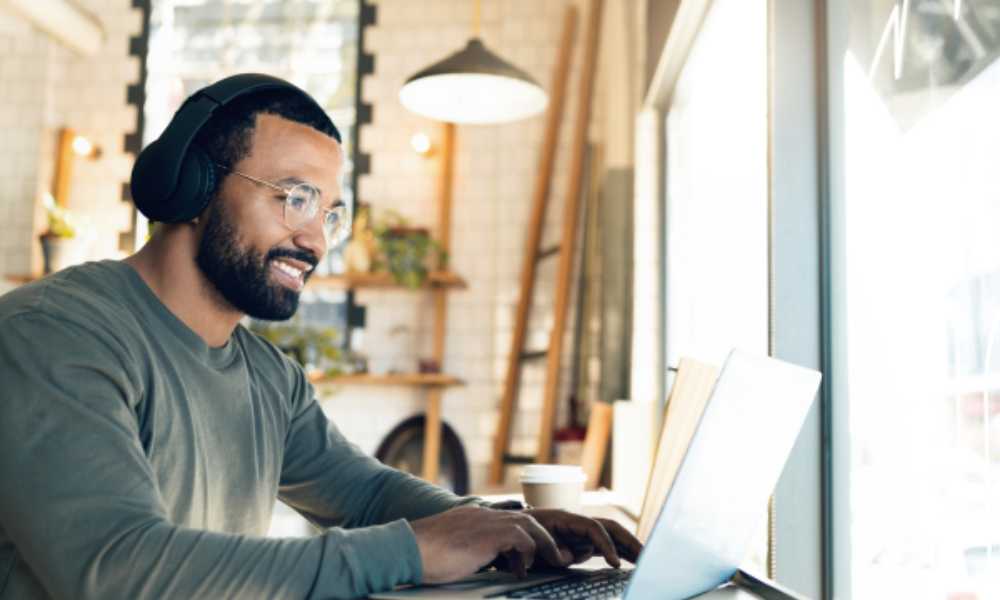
[410, 506, 576, 583]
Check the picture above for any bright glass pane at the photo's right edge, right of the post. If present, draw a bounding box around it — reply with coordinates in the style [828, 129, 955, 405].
[834, 0, 1000, 600]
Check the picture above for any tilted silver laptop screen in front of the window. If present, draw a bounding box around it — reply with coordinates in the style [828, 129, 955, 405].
[626, 350, 820, 598]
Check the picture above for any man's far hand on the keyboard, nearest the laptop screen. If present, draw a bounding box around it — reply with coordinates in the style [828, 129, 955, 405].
[524, 508, 642, 568]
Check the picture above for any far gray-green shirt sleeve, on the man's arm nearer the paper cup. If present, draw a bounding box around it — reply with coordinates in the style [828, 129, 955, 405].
[279, 366, 485, 527]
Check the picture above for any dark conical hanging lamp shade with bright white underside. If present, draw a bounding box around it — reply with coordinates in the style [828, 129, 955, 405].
[399, 38, 549, 124]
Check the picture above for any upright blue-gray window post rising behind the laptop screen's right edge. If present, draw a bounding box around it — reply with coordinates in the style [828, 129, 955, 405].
[768, 0, 837, 598]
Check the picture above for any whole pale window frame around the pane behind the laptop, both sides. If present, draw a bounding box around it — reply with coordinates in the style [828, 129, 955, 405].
[637, 0, 836, 598]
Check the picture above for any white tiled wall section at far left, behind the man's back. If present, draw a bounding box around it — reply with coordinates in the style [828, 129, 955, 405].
[0, 0, 142, 275]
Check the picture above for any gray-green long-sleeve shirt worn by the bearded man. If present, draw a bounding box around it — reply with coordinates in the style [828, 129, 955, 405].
[0, 261, 474, 599]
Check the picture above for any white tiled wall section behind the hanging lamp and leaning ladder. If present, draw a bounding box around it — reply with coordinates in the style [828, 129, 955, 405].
[324, 0, 600, 491]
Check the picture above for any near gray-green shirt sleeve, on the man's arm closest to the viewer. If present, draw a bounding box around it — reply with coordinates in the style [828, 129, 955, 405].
[0, 312, 421, 599]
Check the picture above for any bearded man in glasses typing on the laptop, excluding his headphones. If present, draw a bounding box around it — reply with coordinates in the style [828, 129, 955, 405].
[0, 76, 640, 599]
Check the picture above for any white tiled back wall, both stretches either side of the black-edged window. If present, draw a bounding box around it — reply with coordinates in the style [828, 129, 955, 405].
[0, 0, 624, 490]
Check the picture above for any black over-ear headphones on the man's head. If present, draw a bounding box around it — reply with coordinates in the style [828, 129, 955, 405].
[130, 73, 341, 223]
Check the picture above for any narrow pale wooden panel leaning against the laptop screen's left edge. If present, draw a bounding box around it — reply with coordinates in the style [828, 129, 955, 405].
[638, 358, 719, 542]
